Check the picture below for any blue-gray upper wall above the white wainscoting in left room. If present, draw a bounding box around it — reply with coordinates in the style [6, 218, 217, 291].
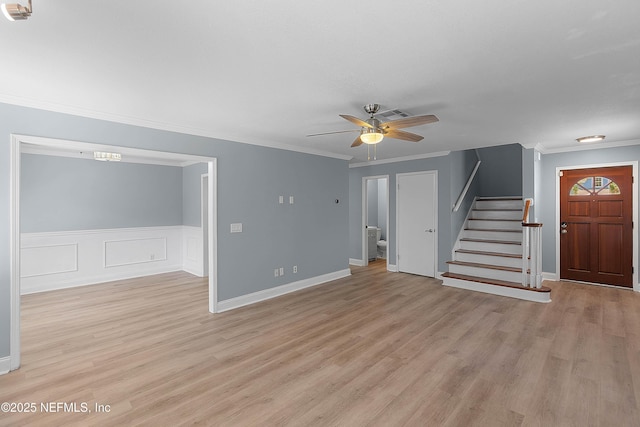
[20, 154, 182, 233]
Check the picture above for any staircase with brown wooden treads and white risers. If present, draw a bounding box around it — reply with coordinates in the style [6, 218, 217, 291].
[442, 197, 551, 302]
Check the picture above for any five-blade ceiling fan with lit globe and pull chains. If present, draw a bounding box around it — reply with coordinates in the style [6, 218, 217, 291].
[307, 104, 438, 147]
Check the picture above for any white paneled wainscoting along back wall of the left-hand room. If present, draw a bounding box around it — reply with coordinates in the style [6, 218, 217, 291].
[20, 226, 188, 294]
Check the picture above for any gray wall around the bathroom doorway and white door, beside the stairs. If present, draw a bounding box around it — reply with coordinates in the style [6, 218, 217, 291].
[349, 152, 476, 271]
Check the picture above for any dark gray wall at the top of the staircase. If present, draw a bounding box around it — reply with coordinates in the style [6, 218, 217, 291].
[478, 144, 522, 197]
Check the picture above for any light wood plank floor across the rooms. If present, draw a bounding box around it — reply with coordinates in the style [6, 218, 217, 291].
[0, 264, 640, 426]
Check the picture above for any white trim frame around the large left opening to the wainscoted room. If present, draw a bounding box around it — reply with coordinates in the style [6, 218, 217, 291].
[9, 134, 218, 371]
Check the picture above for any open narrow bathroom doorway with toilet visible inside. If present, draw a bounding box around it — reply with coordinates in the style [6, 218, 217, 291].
[362, 175, 389, 269]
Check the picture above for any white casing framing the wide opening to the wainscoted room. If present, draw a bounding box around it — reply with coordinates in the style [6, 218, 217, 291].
[9, 135, 217, 370]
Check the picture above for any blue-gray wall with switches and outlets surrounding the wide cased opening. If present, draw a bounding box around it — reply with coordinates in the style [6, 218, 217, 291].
[0, 103, 349, 357]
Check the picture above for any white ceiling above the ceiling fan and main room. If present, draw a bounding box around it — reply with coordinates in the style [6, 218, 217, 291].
[0, 0, 640, 162]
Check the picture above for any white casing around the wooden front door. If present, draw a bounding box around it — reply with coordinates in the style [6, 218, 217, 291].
[554, 160, 640, 292]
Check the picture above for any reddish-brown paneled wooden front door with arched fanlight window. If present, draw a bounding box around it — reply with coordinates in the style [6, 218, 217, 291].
[560, 166, 633, 288]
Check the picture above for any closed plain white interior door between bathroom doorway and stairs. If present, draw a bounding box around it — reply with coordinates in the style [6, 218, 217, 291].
[396, 171, 438, 277]
